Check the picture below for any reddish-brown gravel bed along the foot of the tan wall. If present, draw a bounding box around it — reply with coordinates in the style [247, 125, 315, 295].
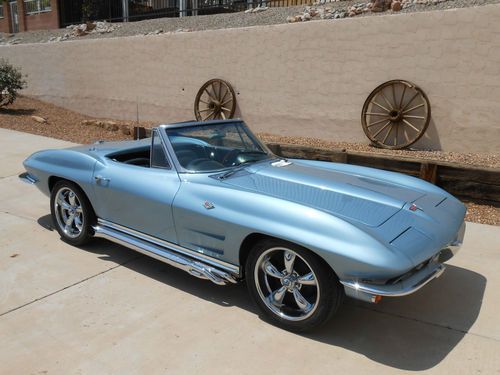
[0, 96, 500, 226]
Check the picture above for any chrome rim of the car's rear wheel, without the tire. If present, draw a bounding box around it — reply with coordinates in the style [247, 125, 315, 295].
[54, 187, 84, 238]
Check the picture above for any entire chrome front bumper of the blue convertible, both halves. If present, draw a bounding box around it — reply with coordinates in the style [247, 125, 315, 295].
[340, 222, 465, 302]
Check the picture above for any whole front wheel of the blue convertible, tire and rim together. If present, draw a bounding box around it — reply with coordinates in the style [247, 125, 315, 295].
[245, 239, 344, 332]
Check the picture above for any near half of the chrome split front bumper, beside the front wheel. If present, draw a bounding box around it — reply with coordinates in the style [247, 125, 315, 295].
[340, 264, 446, 297]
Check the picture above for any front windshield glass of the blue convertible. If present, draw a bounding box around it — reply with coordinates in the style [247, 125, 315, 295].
[166, 122, 274, 172]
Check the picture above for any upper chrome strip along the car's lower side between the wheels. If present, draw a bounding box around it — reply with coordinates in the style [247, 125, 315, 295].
[94, 219, 240, 277]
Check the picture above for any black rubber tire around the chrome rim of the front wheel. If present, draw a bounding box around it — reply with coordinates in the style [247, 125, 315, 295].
[245, 239, 344, 332]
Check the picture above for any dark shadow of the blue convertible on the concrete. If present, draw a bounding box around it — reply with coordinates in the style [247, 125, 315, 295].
[39, 218, 487, 371]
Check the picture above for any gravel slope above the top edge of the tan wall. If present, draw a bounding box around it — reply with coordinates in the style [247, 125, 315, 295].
[0, 0, 500, 44]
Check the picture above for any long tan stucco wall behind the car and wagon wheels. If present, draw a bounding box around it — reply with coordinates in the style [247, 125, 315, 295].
[0, 4, 500, 152]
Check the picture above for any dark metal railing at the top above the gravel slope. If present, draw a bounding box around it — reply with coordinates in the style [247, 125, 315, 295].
[59, 0, 313, 27]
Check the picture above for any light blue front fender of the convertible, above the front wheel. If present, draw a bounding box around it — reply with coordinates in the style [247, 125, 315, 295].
[173, 175, 413, 278]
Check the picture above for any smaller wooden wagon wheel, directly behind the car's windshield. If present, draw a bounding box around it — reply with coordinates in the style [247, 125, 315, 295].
[194, 78, 236, 121]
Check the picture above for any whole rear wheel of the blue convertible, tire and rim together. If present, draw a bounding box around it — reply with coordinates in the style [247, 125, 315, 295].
[50, 180, 95, 246]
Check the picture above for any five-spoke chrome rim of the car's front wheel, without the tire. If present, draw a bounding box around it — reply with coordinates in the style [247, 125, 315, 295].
[254, 247, 320, 321]
